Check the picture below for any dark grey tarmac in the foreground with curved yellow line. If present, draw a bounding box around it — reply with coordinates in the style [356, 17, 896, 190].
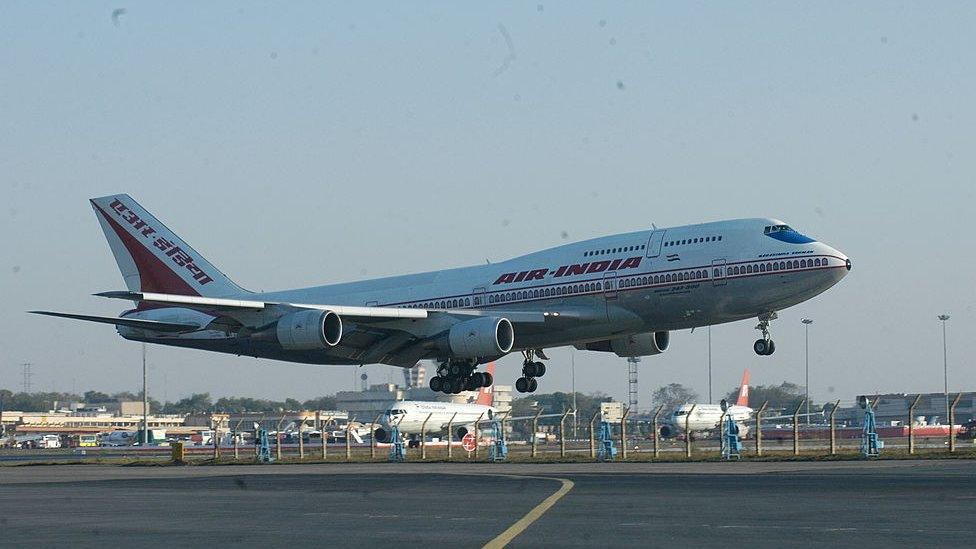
[0, 459, 976, 547]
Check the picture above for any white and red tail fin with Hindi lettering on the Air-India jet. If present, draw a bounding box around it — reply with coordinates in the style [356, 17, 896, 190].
[90, 194, 247, 297]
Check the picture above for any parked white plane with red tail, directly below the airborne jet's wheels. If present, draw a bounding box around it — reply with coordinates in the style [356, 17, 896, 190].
[373, 362, 498, 442]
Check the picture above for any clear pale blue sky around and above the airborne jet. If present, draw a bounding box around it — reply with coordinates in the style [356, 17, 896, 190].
[0, 2, 976, 405]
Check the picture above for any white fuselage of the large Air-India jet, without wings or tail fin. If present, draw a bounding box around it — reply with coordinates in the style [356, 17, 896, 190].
[119, 219, 850, 366]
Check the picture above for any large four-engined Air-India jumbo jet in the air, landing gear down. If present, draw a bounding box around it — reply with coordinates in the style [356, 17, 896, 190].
[30, 194, 851, 394]
